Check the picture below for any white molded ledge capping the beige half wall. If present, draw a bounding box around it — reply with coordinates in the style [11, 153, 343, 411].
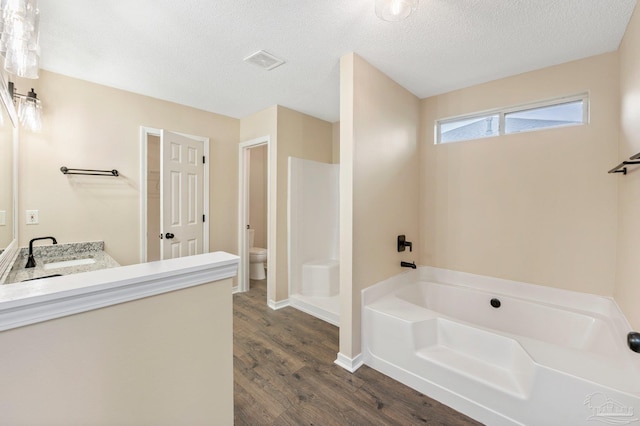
[0, 252, 239, 331]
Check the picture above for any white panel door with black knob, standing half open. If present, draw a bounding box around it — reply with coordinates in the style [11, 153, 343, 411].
[160, 130, 204, 259]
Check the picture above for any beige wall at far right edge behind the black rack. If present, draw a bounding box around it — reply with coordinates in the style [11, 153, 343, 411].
[612, 4, 640, 330]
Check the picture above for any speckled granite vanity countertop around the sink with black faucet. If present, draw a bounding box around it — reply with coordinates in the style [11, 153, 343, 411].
[0, 241, 120, 284]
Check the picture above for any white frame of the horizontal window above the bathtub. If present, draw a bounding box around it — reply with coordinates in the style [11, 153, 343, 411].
[434, 92, 590, 145]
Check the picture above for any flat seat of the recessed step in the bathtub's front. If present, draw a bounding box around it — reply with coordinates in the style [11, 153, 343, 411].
[416, 345, 531, 399]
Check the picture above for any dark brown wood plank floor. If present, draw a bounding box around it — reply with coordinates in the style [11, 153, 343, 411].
[233, 281, 480, 426]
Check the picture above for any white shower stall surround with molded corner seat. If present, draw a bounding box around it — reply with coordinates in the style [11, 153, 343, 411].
[288, 157, 340, 325]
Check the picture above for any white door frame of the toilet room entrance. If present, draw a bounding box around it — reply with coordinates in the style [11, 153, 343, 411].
[237, 136, 276, 292]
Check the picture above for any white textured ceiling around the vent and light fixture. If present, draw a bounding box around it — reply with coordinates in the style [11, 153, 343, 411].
[39, 0, 636, 122]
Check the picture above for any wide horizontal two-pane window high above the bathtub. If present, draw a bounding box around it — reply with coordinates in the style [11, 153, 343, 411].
[436, 94, 589, 143]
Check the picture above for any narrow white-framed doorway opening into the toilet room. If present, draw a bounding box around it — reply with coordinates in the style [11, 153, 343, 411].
[237, 136, 276, 294]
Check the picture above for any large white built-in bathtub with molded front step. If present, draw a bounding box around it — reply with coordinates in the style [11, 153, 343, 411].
[362, 267, 640, 425]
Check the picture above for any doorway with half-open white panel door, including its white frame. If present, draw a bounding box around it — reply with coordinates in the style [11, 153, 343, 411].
[140, 127, 209, 262]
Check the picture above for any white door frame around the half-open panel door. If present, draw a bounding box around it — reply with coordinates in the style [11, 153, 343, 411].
[140, 126, 211, 263]
